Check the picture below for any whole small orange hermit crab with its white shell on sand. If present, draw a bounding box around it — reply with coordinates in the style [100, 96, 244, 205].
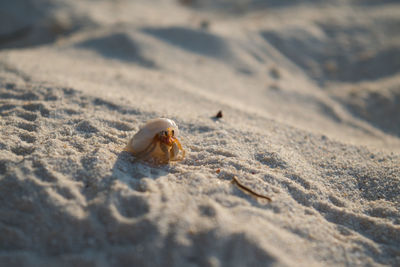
[125, 118, 185, 164]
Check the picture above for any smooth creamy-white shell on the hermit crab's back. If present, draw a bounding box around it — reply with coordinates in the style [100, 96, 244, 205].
[127, 118, 179, 154]
